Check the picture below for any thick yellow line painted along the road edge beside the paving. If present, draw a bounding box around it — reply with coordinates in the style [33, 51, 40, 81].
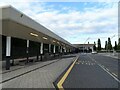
[57, 57, 78, 90]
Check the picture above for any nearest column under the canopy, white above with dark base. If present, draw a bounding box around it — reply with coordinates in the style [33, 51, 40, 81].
[6, 36, 11, 70]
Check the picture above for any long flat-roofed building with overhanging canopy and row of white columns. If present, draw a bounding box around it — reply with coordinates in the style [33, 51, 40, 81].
[0, 6, 75, 70]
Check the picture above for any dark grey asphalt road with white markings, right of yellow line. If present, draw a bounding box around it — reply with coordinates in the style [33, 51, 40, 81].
[63, 54, 120, 89]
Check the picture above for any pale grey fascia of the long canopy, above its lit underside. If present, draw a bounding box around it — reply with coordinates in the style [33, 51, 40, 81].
[0, 5, 74, 47]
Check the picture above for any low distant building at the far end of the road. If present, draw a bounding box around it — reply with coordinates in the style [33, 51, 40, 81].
[74, 44, 94, 53]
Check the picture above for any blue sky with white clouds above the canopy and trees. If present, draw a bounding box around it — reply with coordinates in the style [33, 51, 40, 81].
[0, 0, 118, 47]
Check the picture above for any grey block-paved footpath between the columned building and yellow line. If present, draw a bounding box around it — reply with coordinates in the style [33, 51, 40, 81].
[2, 54, 77, 88]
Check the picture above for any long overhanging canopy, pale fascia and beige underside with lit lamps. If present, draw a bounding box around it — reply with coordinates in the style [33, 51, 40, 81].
[0, 5, 74, 48]
